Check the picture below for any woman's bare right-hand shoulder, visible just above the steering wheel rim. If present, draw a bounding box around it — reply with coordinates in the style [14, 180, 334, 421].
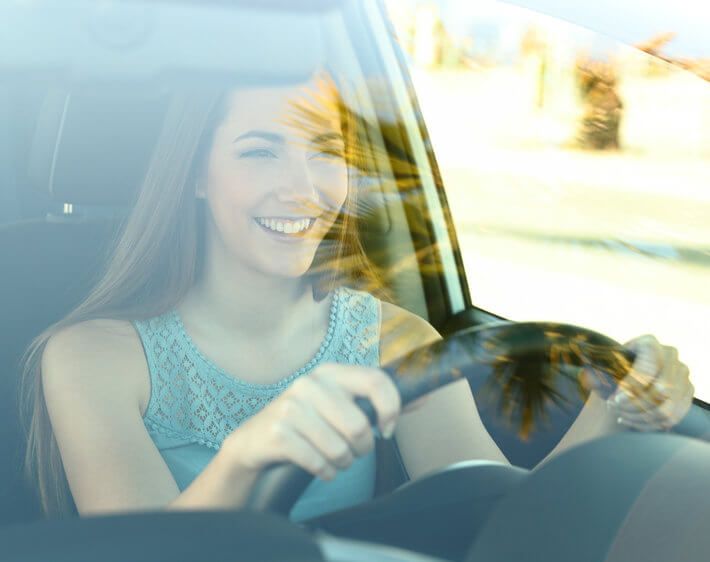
[380, 301, 441, 365]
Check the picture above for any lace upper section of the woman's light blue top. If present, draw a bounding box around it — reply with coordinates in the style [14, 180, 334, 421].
[134, 288, 380, 449]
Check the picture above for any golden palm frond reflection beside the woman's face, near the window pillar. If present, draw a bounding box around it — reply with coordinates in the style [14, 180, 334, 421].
[284, 71, 456, 306]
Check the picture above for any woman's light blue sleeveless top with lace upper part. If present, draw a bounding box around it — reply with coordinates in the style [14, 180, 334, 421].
[134, 287, 380, 521]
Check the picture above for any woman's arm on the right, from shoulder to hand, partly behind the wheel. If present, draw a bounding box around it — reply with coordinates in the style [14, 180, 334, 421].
[380, 303, 694, 478]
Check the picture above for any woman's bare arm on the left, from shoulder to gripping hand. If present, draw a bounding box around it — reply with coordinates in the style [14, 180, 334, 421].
[42, 320, 400, 515]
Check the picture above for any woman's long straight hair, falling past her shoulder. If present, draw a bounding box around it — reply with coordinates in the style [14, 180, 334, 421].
[21, 76, 381, 516]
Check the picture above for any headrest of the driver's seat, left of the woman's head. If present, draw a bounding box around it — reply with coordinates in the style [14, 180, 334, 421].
[28, 89, 167, 206]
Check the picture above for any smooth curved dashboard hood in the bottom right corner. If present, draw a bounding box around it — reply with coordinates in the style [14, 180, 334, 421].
[466, 433, 710, 562]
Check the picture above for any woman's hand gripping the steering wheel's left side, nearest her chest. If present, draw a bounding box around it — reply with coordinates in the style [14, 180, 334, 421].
[226, 363, 401, 480]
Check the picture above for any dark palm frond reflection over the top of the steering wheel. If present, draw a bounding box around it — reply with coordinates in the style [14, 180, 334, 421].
[389, 323, 636, 441]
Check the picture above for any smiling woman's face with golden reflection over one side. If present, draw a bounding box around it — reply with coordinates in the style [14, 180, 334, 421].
[198, 79, 348, 277]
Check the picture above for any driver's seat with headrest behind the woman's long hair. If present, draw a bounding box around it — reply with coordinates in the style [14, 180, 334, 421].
[0, 85, 161, 525]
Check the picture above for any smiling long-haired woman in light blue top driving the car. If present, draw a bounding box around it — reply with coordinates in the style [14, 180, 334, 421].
[20, 76, 412, 514]
